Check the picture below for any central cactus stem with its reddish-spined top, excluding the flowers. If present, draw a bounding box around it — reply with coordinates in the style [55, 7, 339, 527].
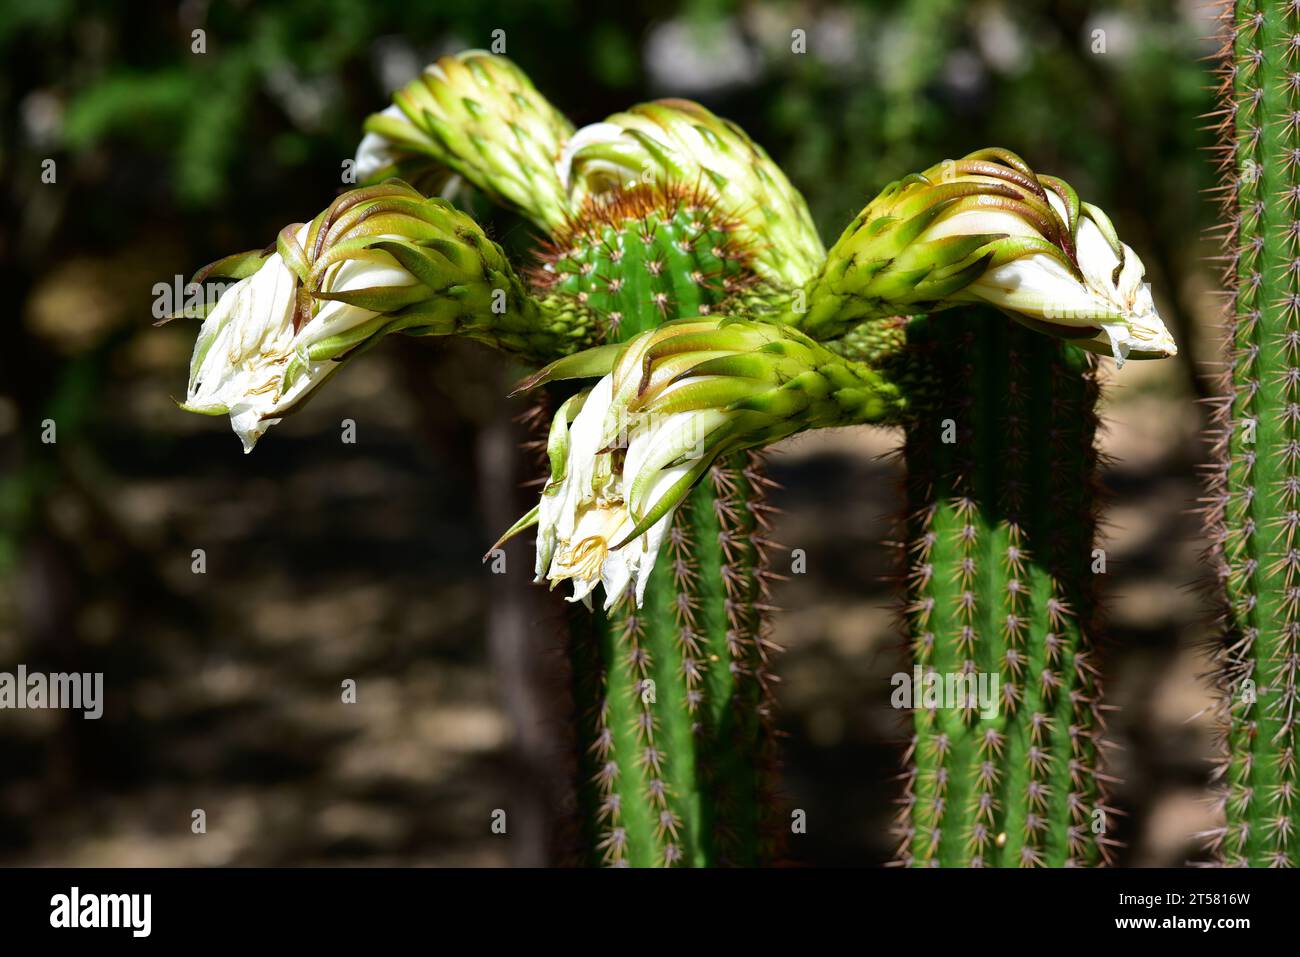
[534, 189, 776, 866]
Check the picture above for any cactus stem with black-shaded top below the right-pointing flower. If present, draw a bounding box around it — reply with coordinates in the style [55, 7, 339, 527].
[896, 312, 1110, 867]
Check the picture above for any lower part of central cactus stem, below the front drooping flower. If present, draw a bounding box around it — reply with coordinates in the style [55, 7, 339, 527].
[572, 455, 779, 866]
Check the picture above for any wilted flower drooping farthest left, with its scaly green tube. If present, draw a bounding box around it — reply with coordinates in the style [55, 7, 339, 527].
[182, 181, 593, 451]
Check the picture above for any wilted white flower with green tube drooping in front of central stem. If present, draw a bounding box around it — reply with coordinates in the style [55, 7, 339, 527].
[498, 319, 906, 609]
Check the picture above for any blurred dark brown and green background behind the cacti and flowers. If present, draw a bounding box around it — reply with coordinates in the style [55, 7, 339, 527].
[0, 0, 1219, 866]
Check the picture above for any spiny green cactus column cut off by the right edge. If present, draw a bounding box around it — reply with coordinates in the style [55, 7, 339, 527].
[1208, 0, 1300, 866]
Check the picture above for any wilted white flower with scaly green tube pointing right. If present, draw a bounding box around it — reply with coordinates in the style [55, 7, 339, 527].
[793, 150, 1178, 365]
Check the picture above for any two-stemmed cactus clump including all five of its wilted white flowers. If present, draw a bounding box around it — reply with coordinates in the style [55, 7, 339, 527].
[172, 52, 1174, 866]
